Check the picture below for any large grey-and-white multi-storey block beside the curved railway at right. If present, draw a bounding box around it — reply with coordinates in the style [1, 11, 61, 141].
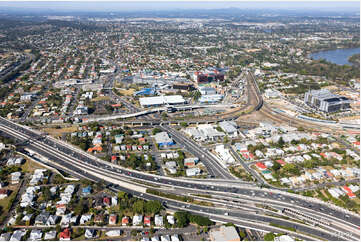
[304, 89, 351, 113]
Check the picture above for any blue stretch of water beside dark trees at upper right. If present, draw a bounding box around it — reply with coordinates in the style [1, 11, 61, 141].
[310, 48, 360, 65]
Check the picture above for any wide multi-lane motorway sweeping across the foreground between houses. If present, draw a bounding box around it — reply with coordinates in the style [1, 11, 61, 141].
[0, 118, 360, 240]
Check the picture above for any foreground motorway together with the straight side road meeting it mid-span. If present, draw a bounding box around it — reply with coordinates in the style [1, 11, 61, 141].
[0, 118, 360, 240]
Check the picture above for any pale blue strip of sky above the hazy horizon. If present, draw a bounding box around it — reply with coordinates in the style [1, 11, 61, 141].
[0, 0, 360, 12]
